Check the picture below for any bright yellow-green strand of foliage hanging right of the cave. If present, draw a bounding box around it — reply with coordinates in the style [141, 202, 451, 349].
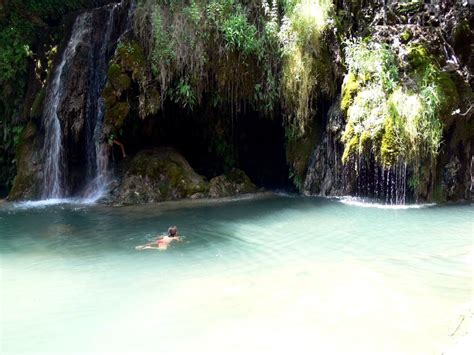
[279, 0, 335, 138]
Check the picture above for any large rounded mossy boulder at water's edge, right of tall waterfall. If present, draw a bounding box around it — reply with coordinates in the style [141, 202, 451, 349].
[111, 148, 209, 204]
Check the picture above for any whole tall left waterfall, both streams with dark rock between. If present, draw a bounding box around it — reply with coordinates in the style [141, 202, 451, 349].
[42, 1, 132, 200]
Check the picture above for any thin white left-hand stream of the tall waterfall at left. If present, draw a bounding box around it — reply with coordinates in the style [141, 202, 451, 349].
[42, 13, 90, 198]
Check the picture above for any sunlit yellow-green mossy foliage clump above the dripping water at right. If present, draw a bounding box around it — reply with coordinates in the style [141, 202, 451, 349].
[341, 40, 457, 171]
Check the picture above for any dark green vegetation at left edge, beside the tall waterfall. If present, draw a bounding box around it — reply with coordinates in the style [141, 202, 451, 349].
[0, 0, 94, 191]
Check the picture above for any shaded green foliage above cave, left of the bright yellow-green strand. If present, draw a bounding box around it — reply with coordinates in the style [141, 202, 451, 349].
[134, 0, 280, 116]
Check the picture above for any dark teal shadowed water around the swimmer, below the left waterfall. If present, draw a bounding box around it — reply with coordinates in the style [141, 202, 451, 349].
[0, 198, 290, 255]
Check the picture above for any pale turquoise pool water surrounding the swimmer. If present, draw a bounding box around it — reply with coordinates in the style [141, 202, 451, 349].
[0, 195, 474, 355]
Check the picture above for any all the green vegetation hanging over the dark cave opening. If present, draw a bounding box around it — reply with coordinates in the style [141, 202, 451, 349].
[122, 0, 337, 181]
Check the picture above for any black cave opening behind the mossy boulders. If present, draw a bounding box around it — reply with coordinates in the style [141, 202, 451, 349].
[117, 104, 293, 191]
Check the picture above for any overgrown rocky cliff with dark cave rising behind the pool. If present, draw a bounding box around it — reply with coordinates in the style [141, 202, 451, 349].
[4, 0, 474, 203]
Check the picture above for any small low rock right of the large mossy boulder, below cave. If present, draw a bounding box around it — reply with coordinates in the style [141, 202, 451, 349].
[209, 169, 257, 198]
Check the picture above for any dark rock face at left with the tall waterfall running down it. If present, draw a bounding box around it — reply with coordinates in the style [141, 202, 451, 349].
[9, 1, 128, 200]
